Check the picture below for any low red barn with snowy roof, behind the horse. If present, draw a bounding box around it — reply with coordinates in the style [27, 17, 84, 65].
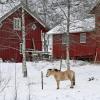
[47, 18, 96, 60]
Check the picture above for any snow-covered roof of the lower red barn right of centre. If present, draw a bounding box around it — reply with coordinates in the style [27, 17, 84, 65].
[47, 17, 95, 35]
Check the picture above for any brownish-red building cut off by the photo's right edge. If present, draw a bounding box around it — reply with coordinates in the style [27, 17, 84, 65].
[90, 1, 100, 62]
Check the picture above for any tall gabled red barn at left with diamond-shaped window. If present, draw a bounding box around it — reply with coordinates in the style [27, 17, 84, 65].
[0, 3, 47, 62]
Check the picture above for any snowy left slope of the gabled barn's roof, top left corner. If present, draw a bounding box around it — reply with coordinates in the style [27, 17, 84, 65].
[0, 0, 20, 18]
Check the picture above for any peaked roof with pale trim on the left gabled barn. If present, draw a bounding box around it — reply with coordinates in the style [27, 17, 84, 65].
[0, 2, 47, 28]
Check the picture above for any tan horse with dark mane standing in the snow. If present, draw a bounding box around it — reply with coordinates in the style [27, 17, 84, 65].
[46, 69, 75, 89]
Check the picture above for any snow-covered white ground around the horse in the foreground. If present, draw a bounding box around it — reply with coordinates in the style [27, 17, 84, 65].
[0, 61, 100, 100]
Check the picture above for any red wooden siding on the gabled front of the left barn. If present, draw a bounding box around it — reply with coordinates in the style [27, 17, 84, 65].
[0, 8, 46, 62]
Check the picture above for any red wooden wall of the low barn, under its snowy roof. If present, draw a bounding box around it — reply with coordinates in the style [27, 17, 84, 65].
[53, 32, 96, 59]
